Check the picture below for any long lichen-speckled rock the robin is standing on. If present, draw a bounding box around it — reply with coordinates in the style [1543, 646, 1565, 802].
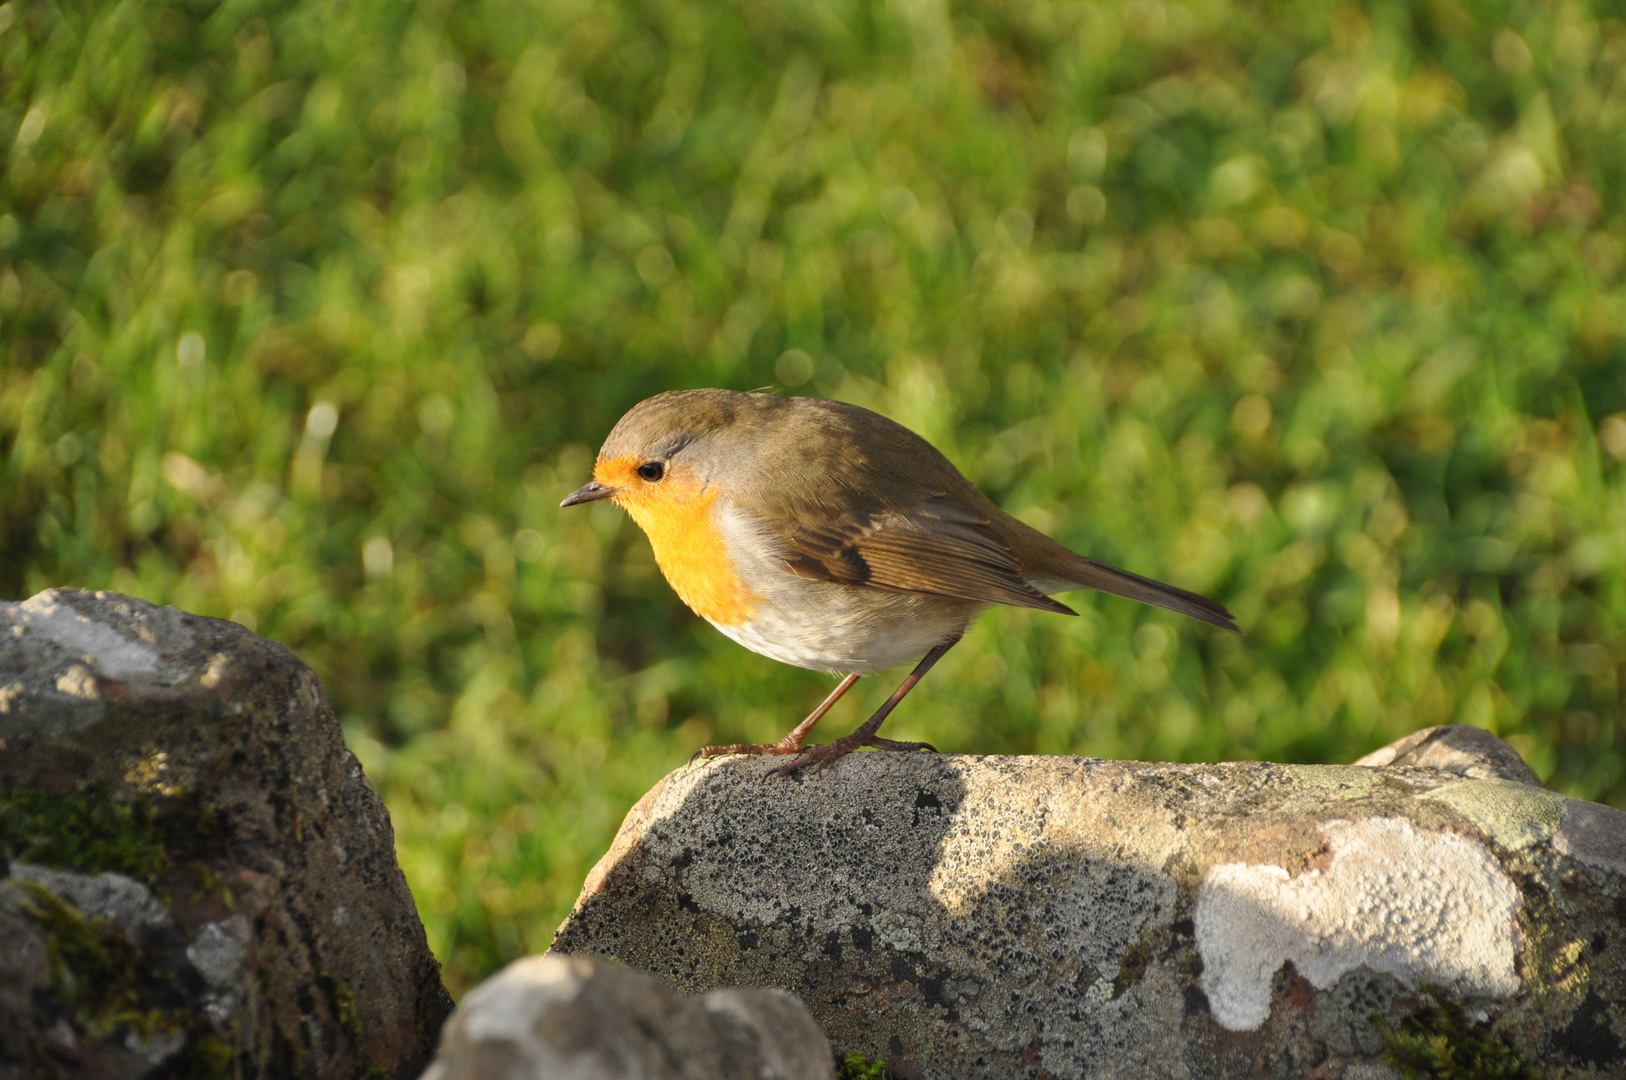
[554, 730, 1626, 1080]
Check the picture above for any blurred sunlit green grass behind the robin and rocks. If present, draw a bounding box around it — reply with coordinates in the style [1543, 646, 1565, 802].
[0, 0, 1626, 991]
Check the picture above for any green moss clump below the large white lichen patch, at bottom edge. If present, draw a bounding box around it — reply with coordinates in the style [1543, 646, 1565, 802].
[1372, 986, 1541, 1080]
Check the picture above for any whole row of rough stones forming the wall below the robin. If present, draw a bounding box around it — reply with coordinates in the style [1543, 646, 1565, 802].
[12, 590, 1626, 1080]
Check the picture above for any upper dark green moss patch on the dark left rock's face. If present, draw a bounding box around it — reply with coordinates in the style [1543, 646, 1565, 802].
[0, 787, 169, 883]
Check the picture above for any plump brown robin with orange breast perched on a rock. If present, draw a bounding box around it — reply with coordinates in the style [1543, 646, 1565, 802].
[559, 390, 1236, 773]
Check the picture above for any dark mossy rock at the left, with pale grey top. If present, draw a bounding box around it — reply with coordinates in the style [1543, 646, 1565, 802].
[0, 590, 450, 1080]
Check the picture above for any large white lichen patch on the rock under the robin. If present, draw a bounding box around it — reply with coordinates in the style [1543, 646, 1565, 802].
[1197, 818, 1519, 1031]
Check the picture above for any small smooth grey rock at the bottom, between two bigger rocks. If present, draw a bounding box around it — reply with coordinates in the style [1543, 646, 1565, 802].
[423, 955, 836, 1080]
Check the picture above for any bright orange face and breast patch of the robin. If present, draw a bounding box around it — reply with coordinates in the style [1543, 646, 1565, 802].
[593, 459, 761, 626]
